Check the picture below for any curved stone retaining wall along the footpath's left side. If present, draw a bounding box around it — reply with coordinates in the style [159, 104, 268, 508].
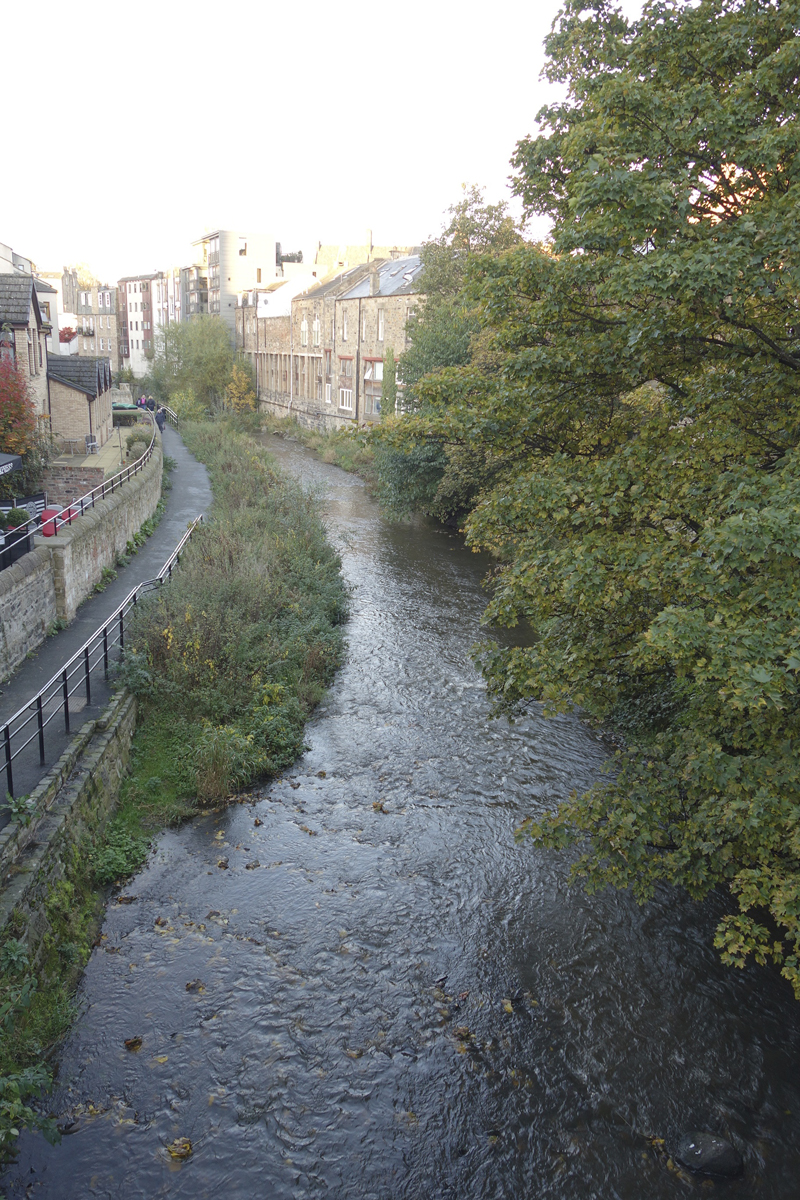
[0, 439, 162, 679]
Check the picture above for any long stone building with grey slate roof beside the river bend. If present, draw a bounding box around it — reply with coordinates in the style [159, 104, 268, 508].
[236, 254, 421, 428]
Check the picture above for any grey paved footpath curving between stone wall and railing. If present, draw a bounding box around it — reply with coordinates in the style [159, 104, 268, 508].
[0, 426, 211, 801]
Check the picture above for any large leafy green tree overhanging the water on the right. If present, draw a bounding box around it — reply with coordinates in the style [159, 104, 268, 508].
[379, 0, 800, 996]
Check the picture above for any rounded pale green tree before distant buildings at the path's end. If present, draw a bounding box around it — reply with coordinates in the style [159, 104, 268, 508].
[149, 316, 234, 412]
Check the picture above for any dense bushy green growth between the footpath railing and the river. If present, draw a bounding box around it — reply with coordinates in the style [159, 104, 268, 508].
[122, 421, 347, 800]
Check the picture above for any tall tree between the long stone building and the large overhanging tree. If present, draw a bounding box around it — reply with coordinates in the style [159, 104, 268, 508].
[374, 184, 521, 522]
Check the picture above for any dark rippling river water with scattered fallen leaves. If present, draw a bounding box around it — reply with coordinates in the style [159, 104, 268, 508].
[4, 438, 800, 1200]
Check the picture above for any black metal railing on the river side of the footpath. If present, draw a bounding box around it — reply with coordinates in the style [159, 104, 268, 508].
[0, 515, 203, 798]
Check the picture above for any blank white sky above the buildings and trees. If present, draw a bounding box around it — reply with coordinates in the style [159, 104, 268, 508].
[0, 0, 639, 283]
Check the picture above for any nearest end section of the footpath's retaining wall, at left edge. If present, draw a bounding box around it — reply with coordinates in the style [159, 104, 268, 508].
[0, 547, 58, 679]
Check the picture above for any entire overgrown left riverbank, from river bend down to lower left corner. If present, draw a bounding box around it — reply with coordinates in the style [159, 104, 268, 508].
[0, 422, 347, 1151]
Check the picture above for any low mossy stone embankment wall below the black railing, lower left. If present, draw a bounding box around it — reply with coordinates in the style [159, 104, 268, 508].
[0, 691, 137, 961]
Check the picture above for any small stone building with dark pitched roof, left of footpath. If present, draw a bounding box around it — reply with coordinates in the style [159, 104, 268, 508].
[47, 354, 113, 450]
